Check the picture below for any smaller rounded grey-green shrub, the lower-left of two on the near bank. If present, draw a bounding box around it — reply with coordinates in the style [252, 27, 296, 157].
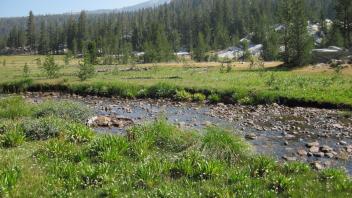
[23, 117, 64, 140]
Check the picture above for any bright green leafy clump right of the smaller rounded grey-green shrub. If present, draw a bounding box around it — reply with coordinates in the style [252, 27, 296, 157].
[65, 123, 95, 143]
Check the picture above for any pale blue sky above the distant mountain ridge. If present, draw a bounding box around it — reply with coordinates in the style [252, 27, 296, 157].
[0, 0, 147, 17]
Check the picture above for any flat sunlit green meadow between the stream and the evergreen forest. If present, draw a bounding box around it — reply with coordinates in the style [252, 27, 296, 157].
[0, 56, 352, 108]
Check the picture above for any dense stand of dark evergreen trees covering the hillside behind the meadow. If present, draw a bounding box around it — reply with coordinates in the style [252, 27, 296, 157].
[0, 0, 352, 65]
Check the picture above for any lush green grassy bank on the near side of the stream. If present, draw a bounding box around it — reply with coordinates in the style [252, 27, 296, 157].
[0, 98, 352, 197]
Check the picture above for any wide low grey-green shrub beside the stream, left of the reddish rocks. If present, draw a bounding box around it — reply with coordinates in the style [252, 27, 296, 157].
[34, 101, 93, 122]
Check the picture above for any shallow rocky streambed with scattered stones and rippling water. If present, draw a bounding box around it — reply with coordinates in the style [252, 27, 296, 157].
[25, 93, 352, 174]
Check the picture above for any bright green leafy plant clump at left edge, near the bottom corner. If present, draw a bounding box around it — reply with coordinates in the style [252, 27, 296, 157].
[0, 166, 21, 197]
